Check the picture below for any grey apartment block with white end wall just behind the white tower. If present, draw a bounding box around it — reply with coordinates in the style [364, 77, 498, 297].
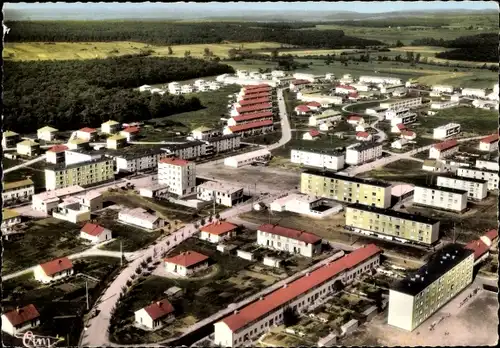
[114, 147, 171, 173]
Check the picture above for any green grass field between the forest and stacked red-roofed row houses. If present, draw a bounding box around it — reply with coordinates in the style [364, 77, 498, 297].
[157, 85, 240, 130]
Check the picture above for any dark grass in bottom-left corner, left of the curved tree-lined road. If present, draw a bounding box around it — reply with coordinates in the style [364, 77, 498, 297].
[2, 257, 119, 346]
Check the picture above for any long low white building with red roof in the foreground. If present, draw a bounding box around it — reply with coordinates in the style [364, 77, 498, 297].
[214, 244, 381, 347]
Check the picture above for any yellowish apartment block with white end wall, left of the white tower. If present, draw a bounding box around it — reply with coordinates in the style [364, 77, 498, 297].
[45, 158, 115, 190]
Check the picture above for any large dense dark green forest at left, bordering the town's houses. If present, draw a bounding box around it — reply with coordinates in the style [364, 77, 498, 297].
[3, 57, 234, 133]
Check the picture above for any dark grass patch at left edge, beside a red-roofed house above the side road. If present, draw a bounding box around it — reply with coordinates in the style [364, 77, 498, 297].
[2, 218, 88, 274]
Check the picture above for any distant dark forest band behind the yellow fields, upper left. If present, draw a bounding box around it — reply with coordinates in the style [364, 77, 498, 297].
[6, 21, 384, 48]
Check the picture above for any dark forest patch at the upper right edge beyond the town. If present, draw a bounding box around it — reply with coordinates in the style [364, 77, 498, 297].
[412, 33, 498, 63]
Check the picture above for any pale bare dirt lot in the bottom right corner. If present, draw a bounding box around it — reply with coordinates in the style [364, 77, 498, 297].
[338, 283, 498, 347]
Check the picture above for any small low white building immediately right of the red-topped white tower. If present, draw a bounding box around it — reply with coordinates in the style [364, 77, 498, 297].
[196, 181, 243, 207]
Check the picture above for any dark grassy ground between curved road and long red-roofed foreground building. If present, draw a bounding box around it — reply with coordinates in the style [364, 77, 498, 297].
[112, 238, 277, 344]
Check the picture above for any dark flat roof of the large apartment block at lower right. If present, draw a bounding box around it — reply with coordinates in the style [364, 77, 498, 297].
[391, 244, 473, 296]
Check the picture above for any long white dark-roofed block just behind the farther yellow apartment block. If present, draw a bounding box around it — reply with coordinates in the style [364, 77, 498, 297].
[290, 149, 345, 170]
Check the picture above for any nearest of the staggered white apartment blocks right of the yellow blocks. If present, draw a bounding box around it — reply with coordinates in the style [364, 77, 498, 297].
[413, 185, 468, 213]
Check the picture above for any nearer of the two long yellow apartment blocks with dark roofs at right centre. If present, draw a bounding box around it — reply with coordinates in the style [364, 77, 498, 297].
[345, 203, 439, 245]
